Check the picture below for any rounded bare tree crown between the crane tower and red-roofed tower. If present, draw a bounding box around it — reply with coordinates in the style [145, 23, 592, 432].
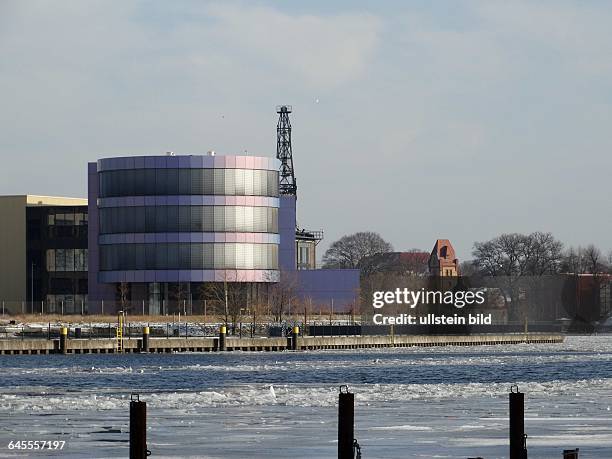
[323, 231, 393, 269]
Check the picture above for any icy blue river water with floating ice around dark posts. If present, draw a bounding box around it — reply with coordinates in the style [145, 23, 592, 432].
[0, 336, 612, 459]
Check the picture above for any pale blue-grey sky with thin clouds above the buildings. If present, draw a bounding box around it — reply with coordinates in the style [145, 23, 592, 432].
[0, 0, 612, 259]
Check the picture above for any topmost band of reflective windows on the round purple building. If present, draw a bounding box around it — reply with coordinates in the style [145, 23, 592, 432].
[99, 169, 278, 198]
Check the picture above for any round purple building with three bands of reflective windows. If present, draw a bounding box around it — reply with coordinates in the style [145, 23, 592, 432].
[89, 155, 280, 313]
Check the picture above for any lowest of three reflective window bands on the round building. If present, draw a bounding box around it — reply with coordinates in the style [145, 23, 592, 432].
[100, 243, 278, 271]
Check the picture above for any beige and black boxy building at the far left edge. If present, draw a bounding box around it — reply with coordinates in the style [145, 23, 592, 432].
[0, 195, 88, 313]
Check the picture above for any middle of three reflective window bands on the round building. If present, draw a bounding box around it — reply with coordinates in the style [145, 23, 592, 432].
[100, 206, 278, 234]
